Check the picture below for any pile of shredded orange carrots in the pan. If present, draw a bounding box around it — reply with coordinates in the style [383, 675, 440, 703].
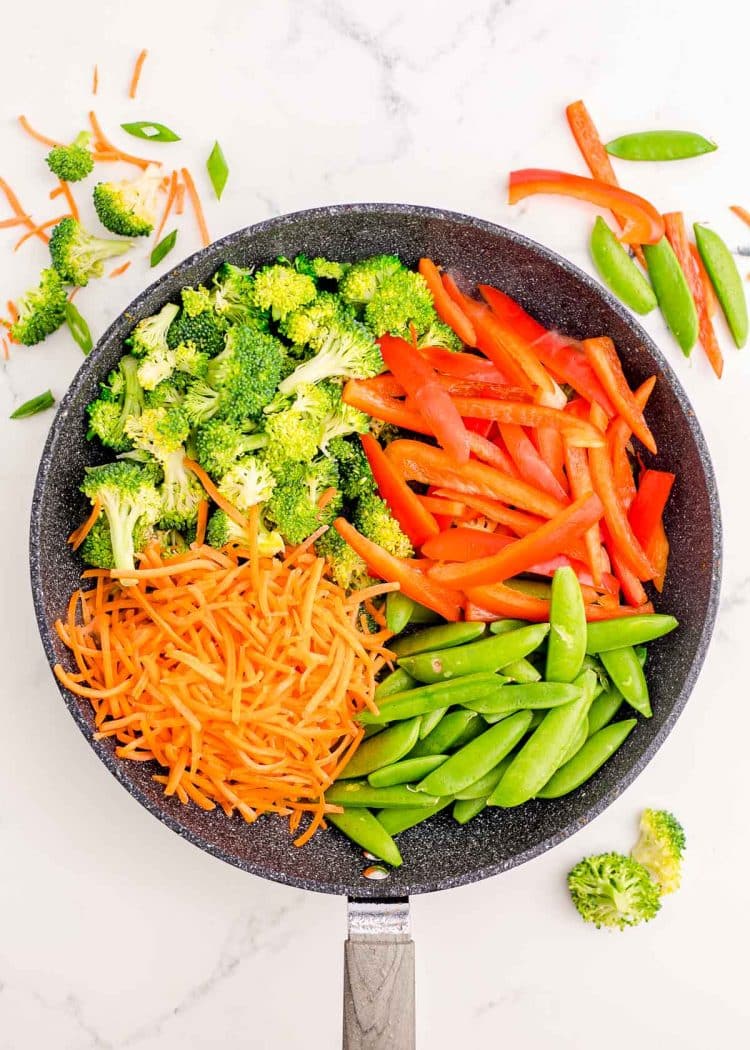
[55, 541, 394, 845]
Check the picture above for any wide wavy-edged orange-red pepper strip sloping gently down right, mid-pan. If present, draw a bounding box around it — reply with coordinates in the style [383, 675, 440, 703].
[386, 440, 562, 518]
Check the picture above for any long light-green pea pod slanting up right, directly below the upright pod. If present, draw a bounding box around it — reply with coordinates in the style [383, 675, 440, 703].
[487, 671, 596, 807]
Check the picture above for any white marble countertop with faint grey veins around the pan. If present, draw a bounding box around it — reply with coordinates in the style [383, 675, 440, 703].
[0, 0, 750, 1050]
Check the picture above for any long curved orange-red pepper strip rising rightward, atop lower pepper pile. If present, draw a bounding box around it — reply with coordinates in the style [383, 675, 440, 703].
[430, 492, 604, 590]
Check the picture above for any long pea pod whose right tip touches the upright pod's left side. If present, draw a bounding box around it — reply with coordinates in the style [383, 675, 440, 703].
[398, 624, 549, 683]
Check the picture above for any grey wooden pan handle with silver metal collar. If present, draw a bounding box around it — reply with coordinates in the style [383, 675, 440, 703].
[342, 898, 416, 1050]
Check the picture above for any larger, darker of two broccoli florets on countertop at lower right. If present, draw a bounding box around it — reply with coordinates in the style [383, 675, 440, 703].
[567, 853, 661, 929]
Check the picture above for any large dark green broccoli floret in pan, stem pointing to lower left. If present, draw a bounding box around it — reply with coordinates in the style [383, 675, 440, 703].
[185, 324, 284, 425]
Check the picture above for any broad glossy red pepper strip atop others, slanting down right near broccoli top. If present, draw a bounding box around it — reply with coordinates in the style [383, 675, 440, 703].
[378, 335, 470, 463]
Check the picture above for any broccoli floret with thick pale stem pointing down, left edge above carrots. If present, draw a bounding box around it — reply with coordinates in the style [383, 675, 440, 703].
[81, 460, 162, 587]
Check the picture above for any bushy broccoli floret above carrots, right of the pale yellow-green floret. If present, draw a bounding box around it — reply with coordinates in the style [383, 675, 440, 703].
[268, 457, 341, 544]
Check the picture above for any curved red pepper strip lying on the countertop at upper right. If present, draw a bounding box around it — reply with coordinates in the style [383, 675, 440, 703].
[507, 168, 664, 245]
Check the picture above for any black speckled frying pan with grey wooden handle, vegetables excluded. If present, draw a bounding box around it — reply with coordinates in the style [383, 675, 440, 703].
[30, 204, 721, 1050]
